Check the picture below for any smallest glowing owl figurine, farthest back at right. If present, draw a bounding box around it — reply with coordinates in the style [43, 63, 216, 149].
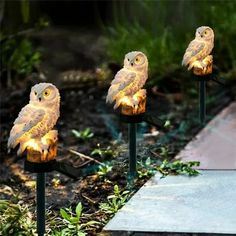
[182, 26, 214, 71]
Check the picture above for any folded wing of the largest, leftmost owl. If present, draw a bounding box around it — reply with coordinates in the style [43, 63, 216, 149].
[7, 104, 45, 148]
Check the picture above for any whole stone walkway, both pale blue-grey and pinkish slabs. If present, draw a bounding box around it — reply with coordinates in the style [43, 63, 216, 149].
[104, 102, 236, 236]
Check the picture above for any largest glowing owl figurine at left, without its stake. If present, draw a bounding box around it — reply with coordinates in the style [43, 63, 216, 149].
[8, 83, 60, 158]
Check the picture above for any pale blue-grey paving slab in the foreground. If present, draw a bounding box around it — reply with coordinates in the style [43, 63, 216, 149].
[104, 170, 236, 235]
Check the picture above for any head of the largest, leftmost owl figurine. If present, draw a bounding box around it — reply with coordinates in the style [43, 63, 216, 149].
[30, 83, 60, 106]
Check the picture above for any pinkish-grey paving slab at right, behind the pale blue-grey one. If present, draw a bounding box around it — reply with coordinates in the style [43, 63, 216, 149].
[176, 102, 236, 169]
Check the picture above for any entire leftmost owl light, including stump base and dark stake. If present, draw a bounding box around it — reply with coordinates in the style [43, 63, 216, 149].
[8, 83, 60, 236]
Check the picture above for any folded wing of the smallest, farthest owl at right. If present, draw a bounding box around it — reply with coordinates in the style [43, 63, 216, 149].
[182, 39, 206, 66]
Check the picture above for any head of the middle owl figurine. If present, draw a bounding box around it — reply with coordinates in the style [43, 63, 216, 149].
[124, 51, 148, 71]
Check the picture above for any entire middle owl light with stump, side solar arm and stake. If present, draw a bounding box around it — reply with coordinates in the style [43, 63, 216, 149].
[106, 51, 164, 186]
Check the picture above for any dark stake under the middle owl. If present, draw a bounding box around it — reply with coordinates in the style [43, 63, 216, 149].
[128, 123, 137, 187]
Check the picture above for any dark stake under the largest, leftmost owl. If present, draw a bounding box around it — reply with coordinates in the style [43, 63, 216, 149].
[37, 173, 46, 236]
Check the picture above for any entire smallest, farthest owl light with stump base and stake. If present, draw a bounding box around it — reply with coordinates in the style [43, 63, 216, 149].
[182, 26, 214, 125]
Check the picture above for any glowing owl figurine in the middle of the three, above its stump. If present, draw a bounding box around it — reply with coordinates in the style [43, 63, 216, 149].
[106, 51, 148, 109]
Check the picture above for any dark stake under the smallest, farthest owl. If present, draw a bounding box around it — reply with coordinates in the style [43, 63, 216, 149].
[199, 81, 206, 125]
